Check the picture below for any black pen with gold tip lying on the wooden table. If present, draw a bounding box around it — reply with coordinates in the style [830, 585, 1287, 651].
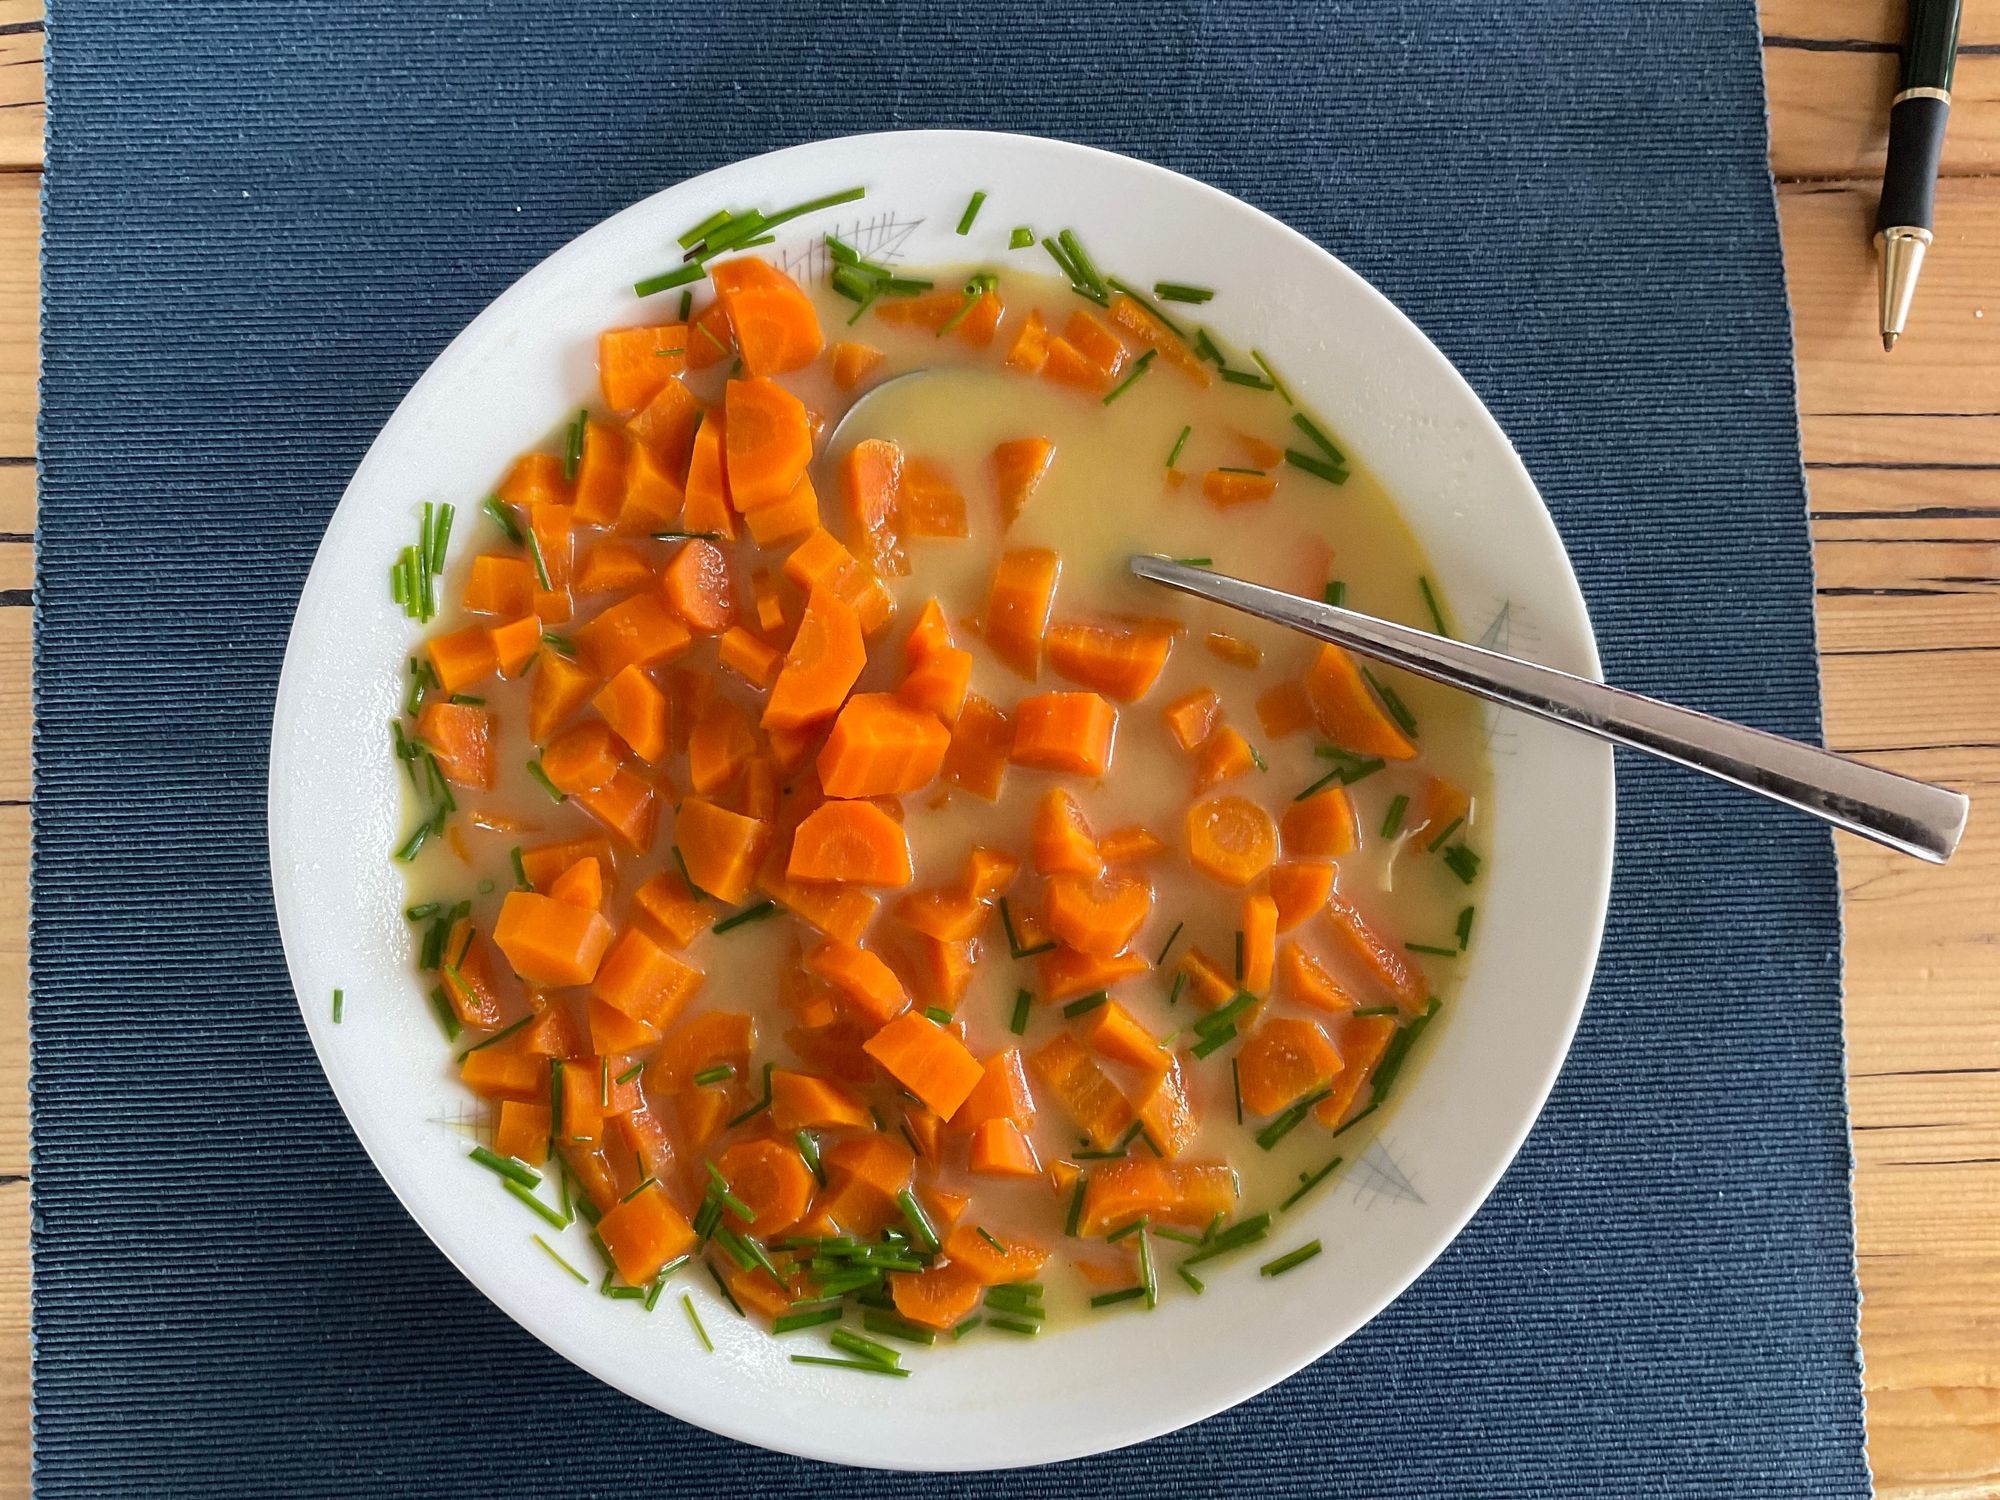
[1876, 0, 1960, 350]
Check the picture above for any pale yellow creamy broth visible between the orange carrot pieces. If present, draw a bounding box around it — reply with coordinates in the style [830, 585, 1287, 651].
[394, 258, 1488, 1322]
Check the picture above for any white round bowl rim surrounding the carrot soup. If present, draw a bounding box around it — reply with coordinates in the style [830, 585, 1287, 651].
[270, 132, 1612, 1470]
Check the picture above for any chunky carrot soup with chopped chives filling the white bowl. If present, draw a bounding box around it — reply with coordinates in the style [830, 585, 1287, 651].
[392, 226, 1484, 1374]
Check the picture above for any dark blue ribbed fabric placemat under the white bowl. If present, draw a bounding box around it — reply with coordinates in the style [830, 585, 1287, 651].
[32, 0, 1866, 1500]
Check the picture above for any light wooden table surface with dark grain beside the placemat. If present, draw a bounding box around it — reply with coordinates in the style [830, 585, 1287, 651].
[0, 0, 2000, 1500]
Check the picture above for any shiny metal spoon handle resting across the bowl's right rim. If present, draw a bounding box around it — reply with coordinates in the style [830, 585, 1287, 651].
[1132, 556, 1970, 864]
